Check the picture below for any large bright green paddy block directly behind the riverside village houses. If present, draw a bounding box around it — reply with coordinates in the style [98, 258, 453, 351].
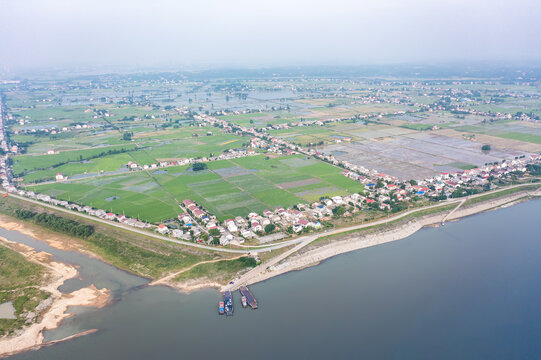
[32, 155, 363, 222]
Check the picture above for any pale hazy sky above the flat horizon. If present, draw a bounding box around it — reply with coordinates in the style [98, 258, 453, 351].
[0, 0, 541, 70]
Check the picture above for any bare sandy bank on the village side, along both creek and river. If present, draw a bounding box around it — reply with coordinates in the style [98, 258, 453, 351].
[0, 184, 539, 302]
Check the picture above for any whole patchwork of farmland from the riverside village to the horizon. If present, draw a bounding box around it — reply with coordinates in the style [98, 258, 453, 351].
[4, 73, 541, 222]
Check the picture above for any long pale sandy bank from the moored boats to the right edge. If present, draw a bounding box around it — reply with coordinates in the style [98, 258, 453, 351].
[228, 189, 541, 291]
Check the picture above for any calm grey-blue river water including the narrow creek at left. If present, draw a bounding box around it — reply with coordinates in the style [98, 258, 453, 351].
[4, 200, 541, 359]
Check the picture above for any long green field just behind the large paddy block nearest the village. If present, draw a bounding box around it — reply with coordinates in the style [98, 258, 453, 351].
[13, 127, 248, 183]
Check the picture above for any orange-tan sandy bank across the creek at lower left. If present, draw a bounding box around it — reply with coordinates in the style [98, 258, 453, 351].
[0, 237, 110, 357]
